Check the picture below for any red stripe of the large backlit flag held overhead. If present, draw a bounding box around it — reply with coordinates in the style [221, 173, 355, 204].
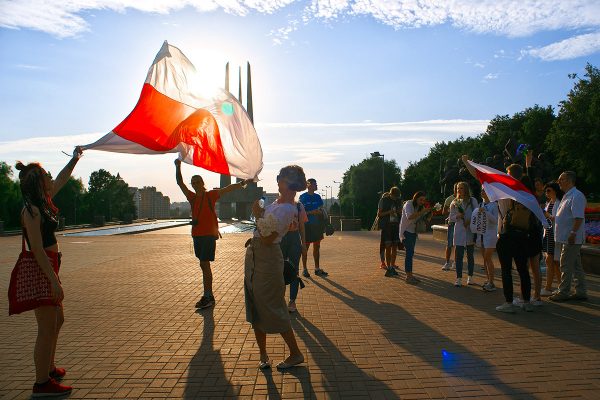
[113, 83, 229, 174]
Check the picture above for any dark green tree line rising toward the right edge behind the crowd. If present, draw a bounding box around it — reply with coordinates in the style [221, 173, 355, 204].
[339, 64, 600, 228]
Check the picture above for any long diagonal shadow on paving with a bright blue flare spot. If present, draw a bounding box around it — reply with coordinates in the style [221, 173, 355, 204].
[312, 278, 535, 399]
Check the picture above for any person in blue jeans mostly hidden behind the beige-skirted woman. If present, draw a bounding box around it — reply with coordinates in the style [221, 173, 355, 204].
[279, 202, 308, 313]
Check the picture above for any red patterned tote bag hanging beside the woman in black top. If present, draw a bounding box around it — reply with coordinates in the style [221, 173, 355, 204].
[8, 237, 62, 315]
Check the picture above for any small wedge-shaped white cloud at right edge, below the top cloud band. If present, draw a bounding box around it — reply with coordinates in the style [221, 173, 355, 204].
[521, 32, 600, 61]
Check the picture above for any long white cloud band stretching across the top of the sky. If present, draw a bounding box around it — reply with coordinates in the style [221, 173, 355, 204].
[0, 0, 600, 37]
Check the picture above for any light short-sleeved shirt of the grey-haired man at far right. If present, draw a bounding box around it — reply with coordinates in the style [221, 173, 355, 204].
[553, 187, 587, 244]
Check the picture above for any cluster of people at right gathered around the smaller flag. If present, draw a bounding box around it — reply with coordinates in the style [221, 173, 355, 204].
[442, 152, 587, 313]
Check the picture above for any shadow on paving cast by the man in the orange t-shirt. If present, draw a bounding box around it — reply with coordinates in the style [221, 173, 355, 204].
[183, 308, 239, 399]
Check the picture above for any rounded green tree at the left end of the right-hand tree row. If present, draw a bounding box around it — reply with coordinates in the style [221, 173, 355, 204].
[339, 157, 402, 228]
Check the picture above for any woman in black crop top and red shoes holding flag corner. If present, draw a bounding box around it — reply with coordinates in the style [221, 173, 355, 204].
[16, 147, 82, 396]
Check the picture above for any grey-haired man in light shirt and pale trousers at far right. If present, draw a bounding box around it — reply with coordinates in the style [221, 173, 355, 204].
[549, 171, 587, 301]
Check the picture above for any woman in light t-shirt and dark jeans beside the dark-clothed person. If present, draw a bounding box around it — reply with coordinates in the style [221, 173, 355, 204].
[400, 191, 432, 285]
